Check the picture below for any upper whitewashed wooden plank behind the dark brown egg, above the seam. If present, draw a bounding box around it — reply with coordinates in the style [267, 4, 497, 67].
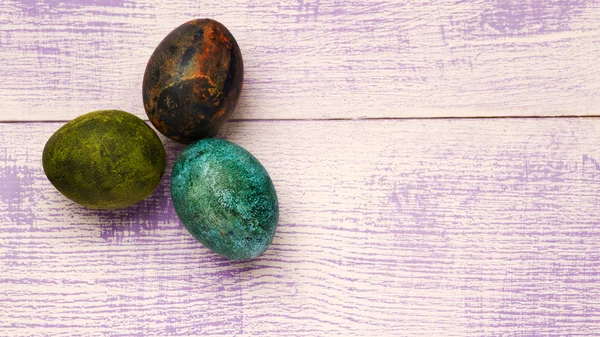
[0, 0, 600, 121]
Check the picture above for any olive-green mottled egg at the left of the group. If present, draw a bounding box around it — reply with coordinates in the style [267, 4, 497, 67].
[42, 110, 166, 209]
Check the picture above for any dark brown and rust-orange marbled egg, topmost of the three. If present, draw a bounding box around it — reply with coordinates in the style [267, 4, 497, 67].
[142, 19, 244, 143]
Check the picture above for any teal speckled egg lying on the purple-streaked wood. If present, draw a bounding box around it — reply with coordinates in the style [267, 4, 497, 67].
[171, 138, 279, 260]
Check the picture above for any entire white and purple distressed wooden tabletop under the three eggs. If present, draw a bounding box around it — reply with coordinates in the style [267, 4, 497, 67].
[0, 0, 600, 337]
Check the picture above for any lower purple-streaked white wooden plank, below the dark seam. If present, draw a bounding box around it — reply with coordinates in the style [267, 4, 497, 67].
[0, 119, 600, 336]
